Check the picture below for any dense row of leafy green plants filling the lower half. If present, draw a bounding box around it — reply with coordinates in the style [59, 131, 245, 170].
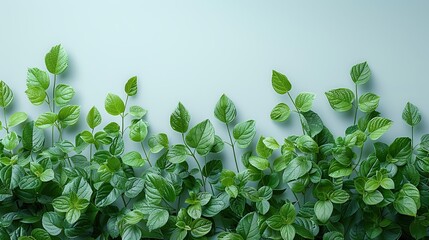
[0, 45, 429, 240]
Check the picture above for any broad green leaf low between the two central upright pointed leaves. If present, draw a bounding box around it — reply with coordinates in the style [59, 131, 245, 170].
[185, 119, 215, 156]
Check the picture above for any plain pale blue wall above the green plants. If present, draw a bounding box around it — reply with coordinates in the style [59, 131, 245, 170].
[0, 0, 429, 160]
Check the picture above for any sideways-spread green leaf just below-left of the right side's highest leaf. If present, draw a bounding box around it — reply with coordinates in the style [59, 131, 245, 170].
[325, 88, 355, 112]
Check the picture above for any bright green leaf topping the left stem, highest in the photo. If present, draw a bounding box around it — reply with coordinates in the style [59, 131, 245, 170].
[45, 44, 68, 75]
